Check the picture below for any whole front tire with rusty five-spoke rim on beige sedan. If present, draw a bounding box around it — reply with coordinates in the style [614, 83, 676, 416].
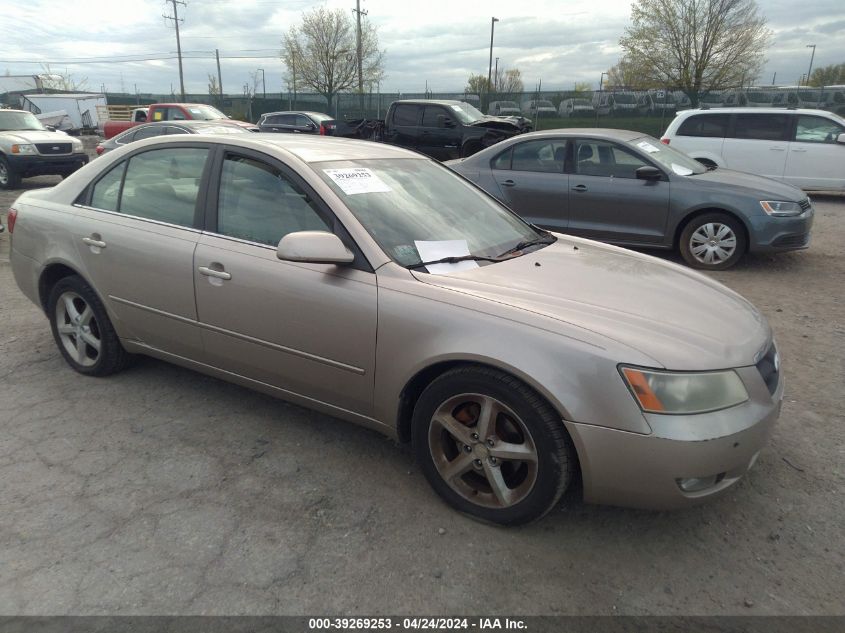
[413, 367, 576, 525]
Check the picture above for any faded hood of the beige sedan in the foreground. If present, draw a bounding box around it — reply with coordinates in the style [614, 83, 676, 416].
[414, 236, 771, 371]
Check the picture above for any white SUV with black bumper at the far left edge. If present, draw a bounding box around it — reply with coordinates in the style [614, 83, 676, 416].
[0, 110, 88, 189]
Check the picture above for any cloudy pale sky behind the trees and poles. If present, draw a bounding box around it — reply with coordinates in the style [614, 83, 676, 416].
[0, 0, 845, 93]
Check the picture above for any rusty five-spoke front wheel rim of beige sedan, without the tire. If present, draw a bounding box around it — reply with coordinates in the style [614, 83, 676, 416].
[428, 393, 538, 509]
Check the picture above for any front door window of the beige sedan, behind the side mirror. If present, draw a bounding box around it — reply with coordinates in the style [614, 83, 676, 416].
[217, 155, 330, 246]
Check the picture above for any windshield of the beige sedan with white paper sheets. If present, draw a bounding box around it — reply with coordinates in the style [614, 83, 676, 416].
[311, 158, 544, 266]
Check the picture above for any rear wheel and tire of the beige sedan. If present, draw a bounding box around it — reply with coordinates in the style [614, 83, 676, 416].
[47, 275, 131, 376]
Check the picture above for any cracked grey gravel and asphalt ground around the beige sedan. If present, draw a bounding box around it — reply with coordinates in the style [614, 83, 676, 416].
[0, 147, 845, 615]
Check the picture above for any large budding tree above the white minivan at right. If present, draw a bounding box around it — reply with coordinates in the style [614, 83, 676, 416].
[619, 0, 771, 105]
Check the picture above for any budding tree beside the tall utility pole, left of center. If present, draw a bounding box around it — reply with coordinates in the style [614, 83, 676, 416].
[281, 7, 384, 111]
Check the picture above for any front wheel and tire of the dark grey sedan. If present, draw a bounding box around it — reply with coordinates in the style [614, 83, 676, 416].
[679, 213, 747, 270]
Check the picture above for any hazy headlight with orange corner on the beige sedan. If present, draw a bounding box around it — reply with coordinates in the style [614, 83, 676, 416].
[619, 366, 748, 414]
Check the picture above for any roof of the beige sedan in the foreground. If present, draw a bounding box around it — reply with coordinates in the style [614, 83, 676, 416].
[123, 132, 431, 163]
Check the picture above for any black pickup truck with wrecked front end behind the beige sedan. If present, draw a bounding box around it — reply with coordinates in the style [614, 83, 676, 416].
[336, 99, 532, 160]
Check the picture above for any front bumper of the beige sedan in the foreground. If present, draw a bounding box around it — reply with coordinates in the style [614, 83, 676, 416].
[565, 366, 783, 510]
